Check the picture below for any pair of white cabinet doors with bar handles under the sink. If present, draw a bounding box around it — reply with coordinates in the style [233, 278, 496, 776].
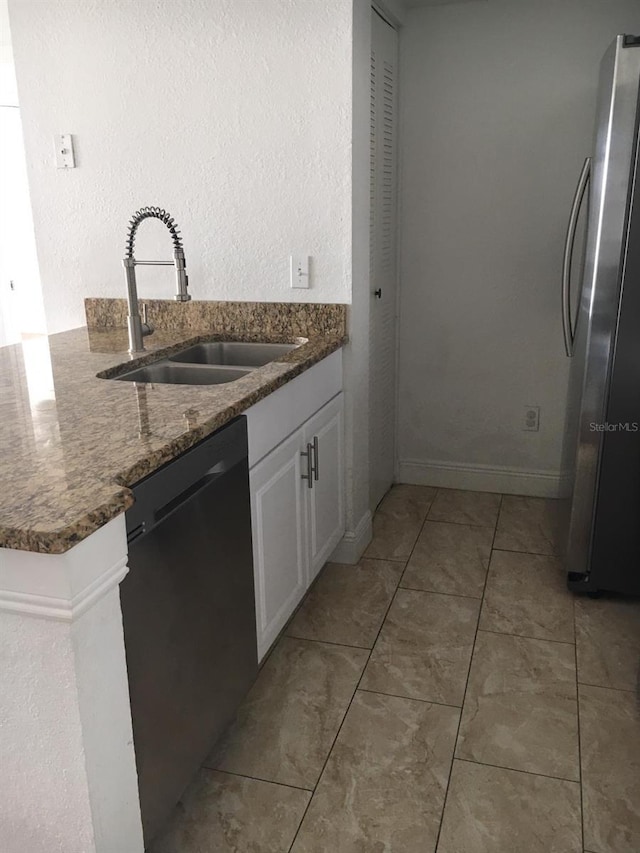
[249, 377, 344, 659]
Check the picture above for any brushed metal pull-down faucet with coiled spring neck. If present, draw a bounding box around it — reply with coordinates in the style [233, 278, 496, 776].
[122, 207, 191, 352]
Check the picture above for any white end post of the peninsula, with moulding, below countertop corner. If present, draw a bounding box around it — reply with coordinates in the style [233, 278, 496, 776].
[0, 515, 143, 853]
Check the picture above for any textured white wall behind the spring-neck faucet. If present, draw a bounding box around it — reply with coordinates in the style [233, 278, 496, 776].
[9, 0, 352, 331]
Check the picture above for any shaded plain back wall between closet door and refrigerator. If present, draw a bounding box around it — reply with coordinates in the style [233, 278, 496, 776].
[399, 0, 640, 489]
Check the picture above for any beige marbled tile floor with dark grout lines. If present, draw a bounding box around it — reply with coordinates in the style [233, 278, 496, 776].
[152, 485, 640, 853]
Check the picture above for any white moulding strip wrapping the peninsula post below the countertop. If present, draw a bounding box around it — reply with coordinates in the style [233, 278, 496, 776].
[0, 557, 129, 622]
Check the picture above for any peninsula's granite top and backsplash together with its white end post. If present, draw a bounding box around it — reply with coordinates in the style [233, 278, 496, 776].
[0, 300, 345, 853]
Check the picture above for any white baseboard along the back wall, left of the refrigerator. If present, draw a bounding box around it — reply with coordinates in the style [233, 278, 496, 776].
[398, 459, 561, 498]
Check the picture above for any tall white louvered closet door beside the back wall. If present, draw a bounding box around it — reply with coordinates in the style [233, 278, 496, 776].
[369, 9, 398, 509]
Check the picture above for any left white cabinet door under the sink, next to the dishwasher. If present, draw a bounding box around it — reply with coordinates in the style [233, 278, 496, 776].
[249, 430, 308, 659]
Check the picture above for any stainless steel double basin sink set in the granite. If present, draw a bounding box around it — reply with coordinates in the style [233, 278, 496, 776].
[115, 341, 298, 385]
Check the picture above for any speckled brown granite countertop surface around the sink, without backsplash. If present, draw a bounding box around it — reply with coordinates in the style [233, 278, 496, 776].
[0, 303, 346, 554]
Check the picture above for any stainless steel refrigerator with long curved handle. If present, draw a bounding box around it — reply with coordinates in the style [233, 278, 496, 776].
[561, 35, 640, 594]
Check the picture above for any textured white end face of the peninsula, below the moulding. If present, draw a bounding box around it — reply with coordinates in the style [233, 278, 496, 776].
[0, 611, 95, 853]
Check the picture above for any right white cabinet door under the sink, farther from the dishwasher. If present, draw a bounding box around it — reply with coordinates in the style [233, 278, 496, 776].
[304, 394, 345, 583]
